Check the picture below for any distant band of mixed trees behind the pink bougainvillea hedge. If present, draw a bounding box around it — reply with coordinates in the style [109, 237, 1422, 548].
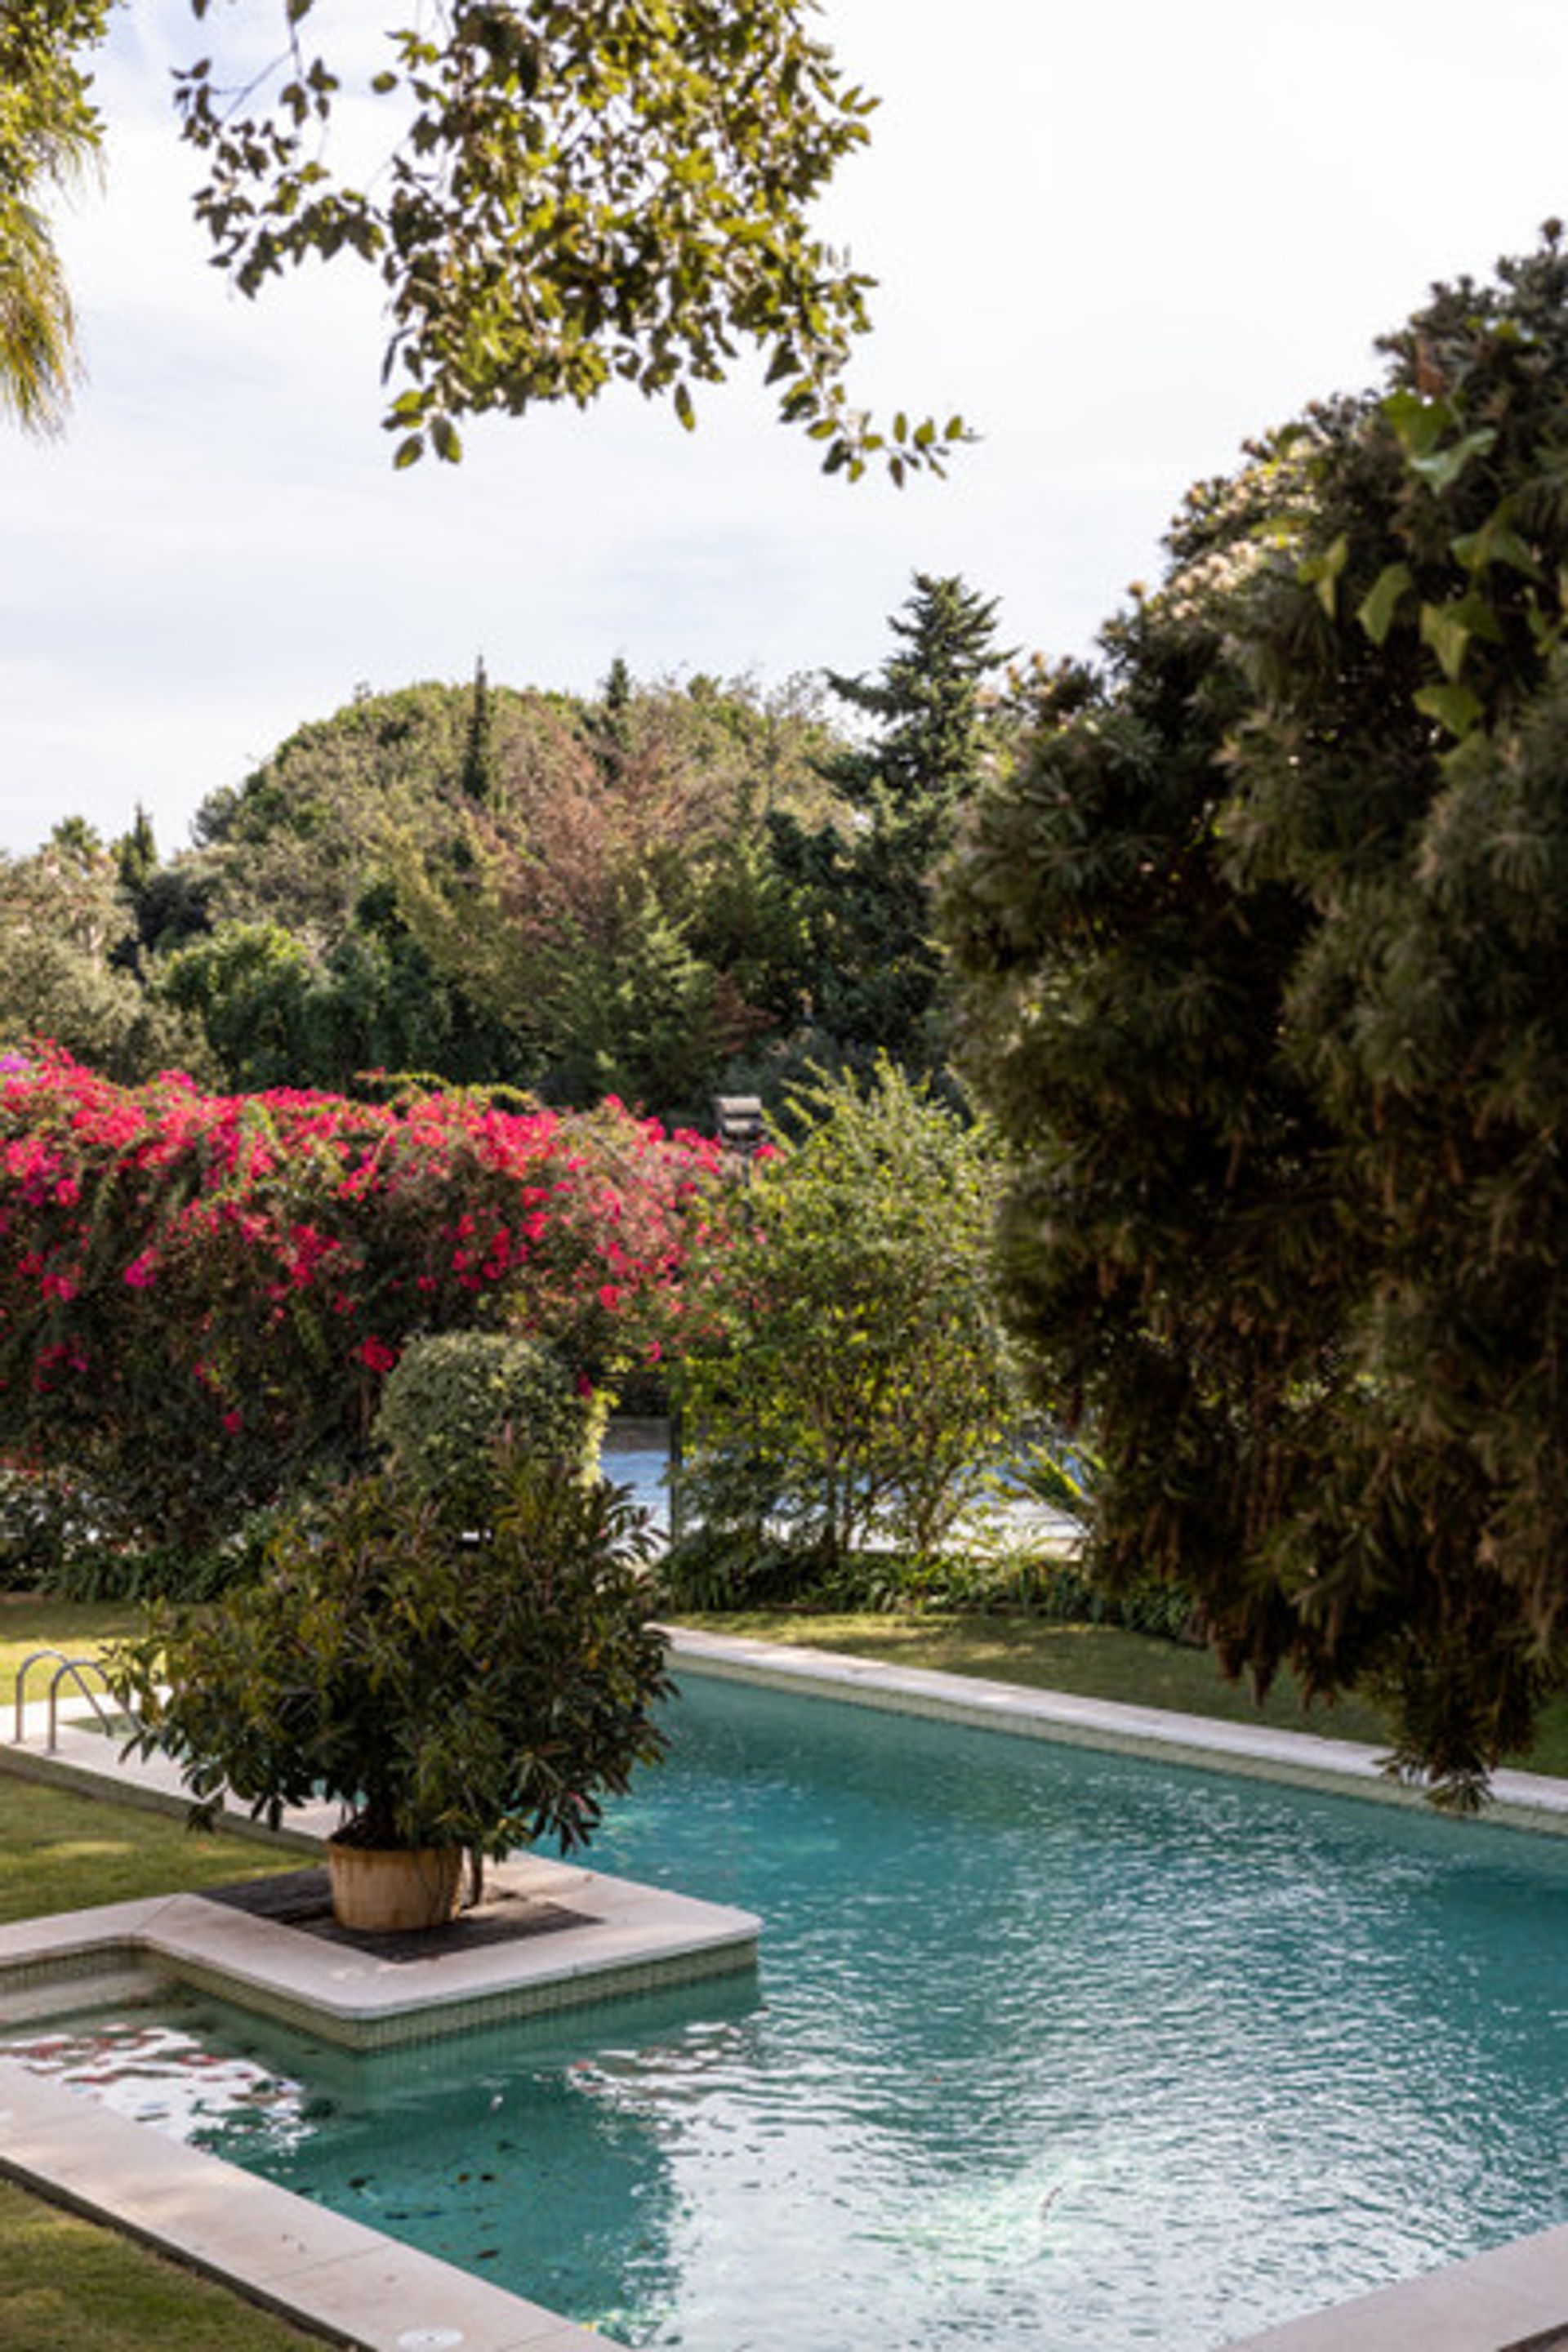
[0, 602, 1016, 1125]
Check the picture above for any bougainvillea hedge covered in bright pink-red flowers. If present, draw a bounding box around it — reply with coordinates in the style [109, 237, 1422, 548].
[0, 1047, 717, 1580]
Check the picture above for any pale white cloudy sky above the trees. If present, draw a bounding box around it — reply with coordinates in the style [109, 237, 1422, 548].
[0, 0, 1568, 852]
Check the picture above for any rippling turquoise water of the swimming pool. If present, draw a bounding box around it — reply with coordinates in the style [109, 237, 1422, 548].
[12, 1677, 1568, 2352]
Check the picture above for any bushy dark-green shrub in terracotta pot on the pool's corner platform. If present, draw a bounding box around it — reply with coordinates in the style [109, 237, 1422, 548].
[113, 1345, 670, 1927]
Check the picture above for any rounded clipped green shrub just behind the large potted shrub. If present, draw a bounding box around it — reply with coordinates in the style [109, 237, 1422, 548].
[374, 1331, 609, 1521]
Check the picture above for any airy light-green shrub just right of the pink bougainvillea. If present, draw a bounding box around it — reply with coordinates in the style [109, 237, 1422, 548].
[679, 1061, 1020, 1578]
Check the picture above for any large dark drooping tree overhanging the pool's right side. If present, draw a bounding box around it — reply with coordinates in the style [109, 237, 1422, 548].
[950, 225, 1568, 1799]
